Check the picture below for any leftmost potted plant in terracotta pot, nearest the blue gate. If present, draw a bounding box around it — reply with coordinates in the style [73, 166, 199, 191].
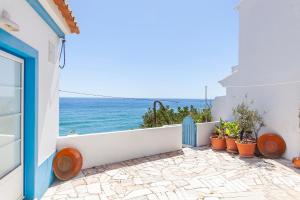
[210, 119, 226, 151]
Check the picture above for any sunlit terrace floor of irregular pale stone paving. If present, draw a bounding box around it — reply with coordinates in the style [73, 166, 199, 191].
[43, 148, 300, 200]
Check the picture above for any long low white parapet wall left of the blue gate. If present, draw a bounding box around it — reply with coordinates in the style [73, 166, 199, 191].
[57, 125, 182, 168]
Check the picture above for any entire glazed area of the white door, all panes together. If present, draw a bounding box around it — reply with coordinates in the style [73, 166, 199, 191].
[0, 55, 22, 179]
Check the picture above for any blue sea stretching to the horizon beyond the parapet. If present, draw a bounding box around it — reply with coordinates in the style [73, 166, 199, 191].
[59, 98, 209, 136]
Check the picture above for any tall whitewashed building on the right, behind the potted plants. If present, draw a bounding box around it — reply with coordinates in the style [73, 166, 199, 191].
[213, 0, 300, 159]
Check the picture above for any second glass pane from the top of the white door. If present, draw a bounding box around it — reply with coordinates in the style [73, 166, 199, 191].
[0, 86, 21, 116]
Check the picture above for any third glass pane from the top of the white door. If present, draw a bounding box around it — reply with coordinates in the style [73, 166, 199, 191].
[0, 115, 21, 147]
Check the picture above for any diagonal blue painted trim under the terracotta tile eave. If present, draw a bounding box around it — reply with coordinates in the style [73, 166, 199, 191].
[26, 0, 65, 38]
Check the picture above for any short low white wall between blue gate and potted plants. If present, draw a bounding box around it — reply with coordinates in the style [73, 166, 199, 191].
[196, 122, 219, 147]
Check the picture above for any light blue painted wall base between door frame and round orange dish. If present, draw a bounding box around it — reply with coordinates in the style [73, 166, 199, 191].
[36, 152, 56, 199]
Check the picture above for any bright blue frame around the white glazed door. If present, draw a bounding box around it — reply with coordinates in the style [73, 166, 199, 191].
[0, 28, 38, 200]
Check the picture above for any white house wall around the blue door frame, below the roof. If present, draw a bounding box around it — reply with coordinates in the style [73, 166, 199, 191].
[0, 0, 59, 164]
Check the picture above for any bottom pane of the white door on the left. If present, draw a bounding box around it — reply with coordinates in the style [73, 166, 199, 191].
[0, 141, 21, 178]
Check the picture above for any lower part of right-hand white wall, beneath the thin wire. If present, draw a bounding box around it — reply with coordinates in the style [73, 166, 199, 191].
[214, 83, 300, 159]
